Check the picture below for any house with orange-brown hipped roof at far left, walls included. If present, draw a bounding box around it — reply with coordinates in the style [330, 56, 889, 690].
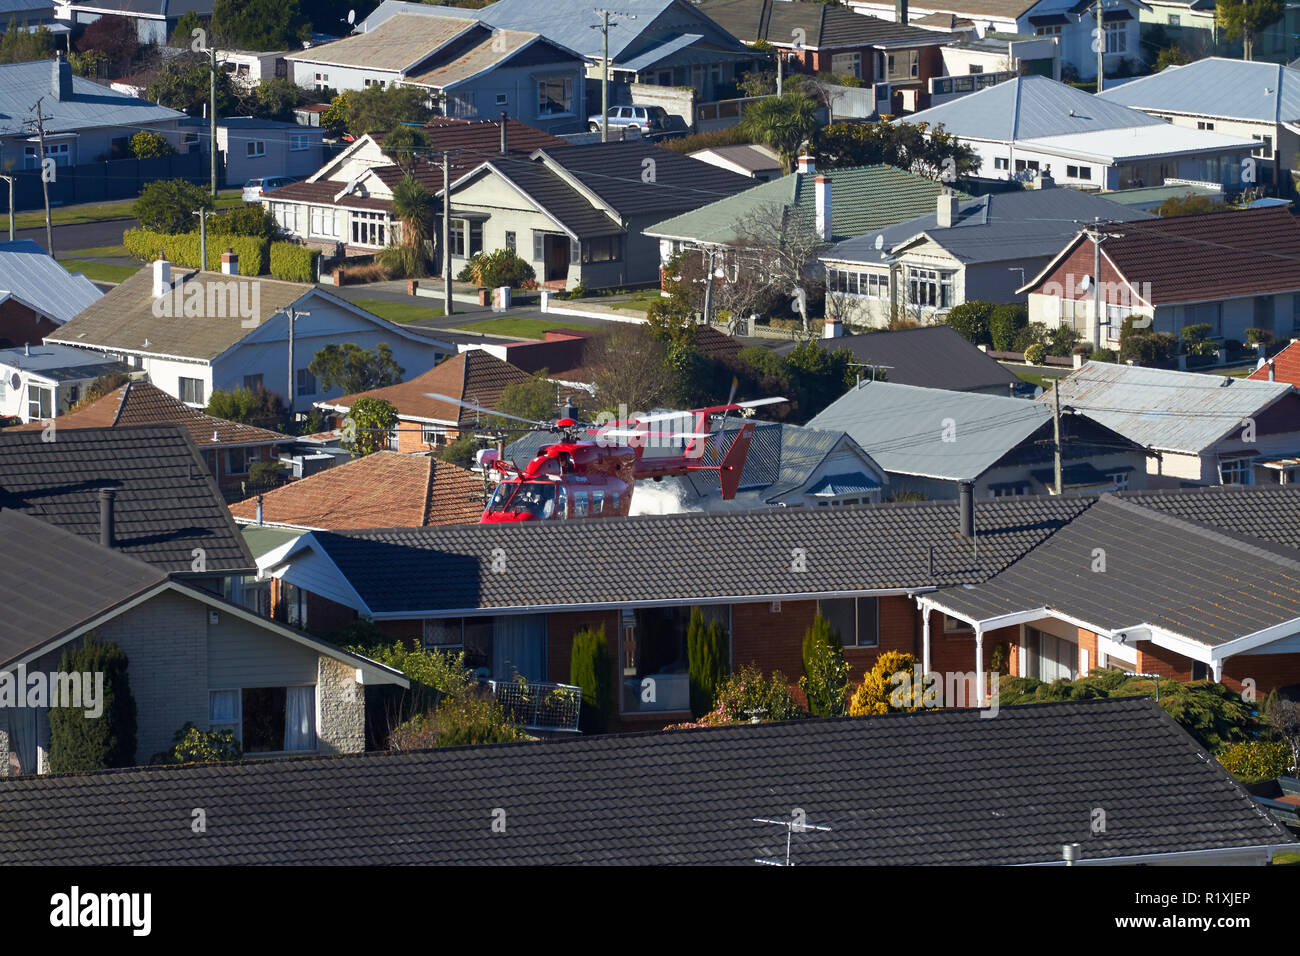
[6, 377, 289, 489]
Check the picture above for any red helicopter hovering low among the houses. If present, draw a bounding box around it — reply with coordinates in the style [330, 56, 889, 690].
[429, 393, 787, 524]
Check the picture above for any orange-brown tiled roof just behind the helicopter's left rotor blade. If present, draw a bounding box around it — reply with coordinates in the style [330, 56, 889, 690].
[321, 349, 528, 425]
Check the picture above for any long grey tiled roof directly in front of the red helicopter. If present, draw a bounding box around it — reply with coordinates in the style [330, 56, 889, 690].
[295, 496, 1095, 617]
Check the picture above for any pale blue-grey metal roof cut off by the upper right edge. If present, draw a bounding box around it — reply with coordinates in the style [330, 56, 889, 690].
[1097, 56, 1300, 122]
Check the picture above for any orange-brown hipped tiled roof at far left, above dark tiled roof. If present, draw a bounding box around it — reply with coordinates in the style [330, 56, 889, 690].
[13, 381, 287, 451]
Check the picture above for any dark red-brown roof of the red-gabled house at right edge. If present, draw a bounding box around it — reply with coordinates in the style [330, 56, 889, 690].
[1075, 206, 1300, 306]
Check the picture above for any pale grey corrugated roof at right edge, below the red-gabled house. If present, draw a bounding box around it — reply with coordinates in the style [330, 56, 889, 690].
[1040, 362, 1291, 454]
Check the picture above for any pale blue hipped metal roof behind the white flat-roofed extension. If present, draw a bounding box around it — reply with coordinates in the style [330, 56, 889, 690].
[907, 77, 1169, 140]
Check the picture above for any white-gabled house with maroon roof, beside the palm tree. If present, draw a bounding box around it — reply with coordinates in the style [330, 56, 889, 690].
[261, 117, 568, 255]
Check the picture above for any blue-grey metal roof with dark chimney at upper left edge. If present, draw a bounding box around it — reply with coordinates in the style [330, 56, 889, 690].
[0, 60, 185, 137]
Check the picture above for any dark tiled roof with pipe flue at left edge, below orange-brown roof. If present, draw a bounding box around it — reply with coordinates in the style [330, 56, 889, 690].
[0, 429, 256, 574]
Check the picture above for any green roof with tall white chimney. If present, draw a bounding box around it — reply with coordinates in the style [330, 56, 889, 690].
[645, 165, 969, 246]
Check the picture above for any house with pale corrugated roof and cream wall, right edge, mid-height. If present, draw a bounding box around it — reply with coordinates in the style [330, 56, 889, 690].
[1043, 362, 1300, 488]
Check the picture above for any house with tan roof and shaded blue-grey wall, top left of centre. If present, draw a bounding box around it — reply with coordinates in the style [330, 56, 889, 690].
[285, 7, 586, 133]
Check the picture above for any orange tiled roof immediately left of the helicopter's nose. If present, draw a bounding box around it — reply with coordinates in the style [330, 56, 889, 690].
[230, 451, 484, 531]
